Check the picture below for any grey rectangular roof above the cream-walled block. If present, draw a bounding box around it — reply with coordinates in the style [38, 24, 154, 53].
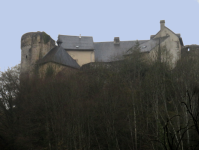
[58, 35, 94, 50]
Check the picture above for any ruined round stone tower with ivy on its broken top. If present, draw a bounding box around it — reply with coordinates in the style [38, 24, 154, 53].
[21, 32, 55, 75]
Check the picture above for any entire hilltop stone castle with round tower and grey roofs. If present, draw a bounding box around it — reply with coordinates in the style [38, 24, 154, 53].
[21, 20, 199, 76]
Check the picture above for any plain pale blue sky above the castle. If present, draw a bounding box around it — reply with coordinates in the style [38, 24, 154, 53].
[0, 0, 199, 71]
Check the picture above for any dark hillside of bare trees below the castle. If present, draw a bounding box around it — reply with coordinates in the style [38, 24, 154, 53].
[0, 48, 199, 150]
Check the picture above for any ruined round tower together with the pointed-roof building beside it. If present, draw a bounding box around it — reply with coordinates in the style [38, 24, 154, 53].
[21, 32, 80, 77]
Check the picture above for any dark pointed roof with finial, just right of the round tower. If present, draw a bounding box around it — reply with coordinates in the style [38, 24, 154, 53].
[38, 46, 80, 68]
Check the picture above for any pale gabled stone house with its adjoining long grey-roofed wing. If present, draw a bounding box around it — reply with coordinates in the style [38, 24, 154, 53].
[94, 20, 184, 64]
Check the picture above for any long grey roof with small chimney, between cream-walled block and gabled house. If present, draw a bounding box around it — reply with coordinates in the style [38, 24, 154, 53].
[94, 40, 148, 62]
